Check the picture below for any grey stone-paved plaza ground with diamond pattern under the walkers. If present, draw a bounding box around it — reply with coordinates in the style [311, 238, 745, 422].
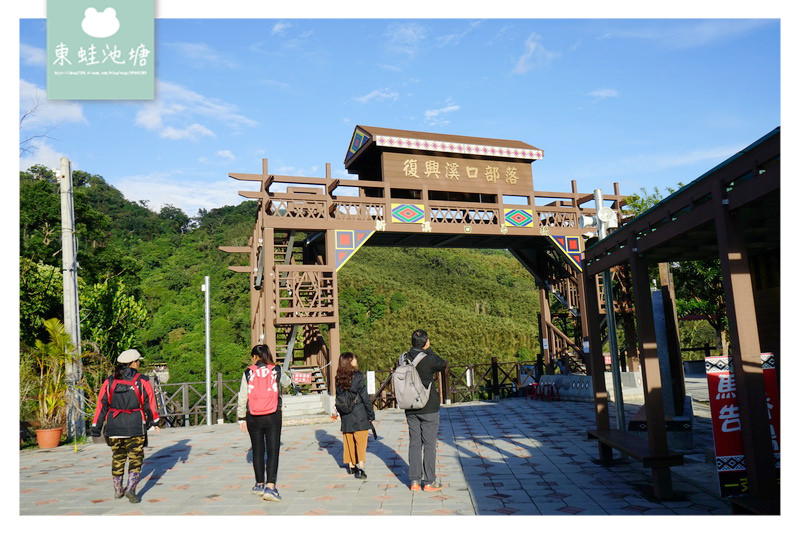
[19, 398, 730, 516]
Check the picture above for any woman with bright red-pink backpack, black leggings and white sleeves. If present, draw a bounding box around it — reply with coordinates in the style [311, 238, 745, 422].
[236, 344, 283, 502]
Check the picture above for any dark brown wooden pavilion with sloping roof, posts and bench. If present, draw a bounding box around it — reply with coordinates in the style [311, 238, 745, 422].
[582, 127, 780, 513]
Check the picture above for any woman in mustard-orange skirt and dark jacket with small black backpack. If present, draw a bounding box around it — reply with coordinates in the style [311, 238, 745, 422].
[335, 352, 375, 479]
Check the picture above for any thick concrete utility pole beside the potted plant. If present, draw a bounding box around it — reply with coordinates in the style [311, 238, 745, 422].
[58, 157, 86, 439]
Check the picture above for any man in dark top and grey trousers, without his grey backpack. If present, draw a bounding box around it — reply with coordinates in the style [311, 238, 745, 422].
[400, 329, 447, 491]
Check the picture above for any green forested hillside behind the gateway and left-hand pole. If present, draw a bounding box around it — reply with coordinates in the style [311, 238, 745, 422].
[20, 167, 538, 390]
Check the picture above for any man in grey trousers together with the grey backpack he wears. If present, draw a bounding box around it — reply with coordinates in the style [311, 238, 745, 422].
[392, 329, 447, 492]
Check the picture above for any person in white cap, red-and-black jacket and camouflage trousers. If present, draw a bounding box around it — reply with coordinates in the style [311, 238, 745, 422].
[91, 350, 159, 503]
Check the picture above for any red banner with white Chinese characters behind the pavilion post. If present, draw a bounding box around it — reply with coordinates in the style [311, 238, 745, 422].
[705, 353, 780, 497]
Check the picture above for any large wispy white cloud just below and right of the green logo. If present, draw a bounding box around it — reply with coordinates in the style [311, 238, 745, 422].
[135, 81, 258, 140]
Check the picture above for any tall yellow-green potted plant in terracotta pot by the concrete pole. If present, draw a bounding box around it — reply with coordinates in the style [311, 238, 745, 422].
[29, 318, 73, 448]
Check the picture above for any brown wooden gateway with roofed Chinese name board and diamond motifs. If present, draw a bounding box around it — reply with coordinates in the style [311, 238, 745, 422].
[221, 126, 624, 392]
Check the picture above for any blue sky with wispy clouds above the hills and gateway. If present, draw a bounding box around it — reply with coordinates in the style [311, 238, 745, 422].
[19, 12, 781, 215]
